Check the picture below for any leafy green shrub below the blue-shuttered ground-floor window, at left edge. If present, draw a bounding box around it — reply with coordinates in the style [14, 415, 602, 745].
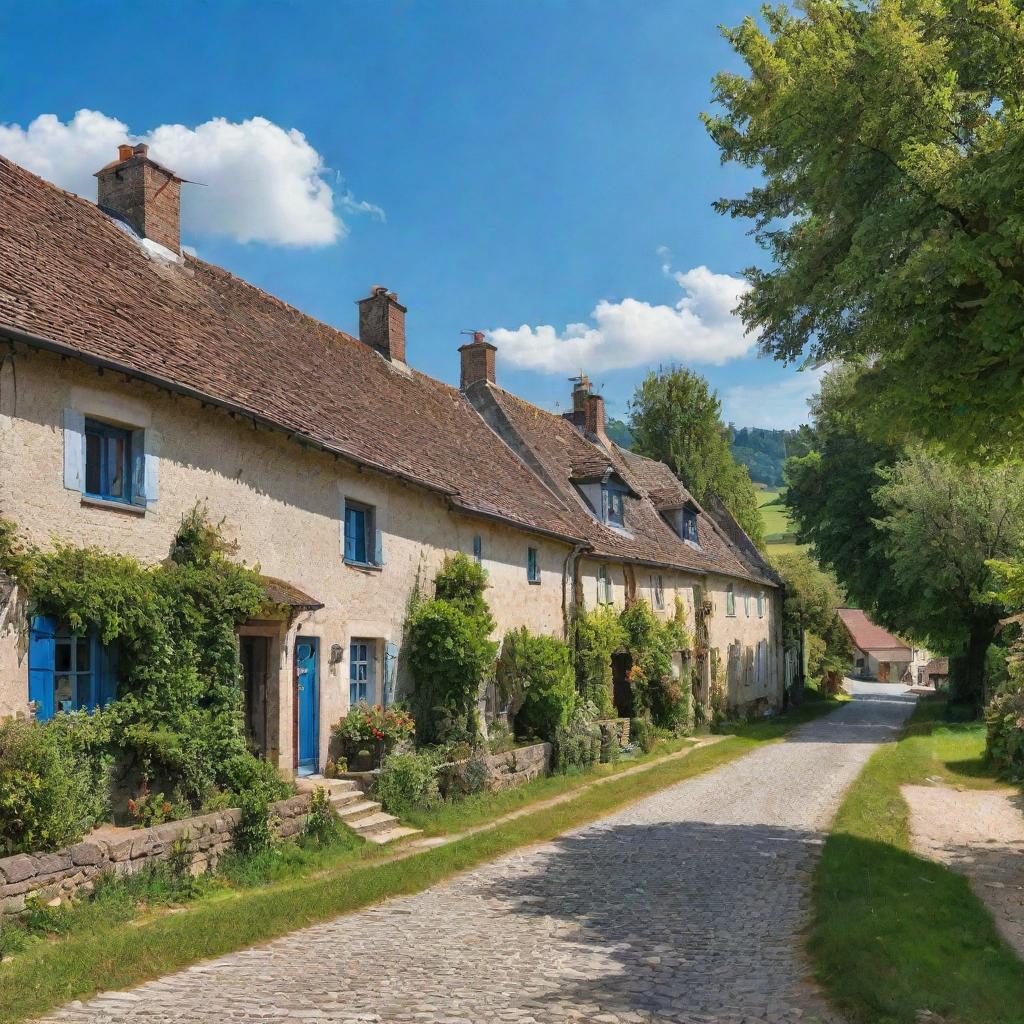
[0, 712, 111, 856]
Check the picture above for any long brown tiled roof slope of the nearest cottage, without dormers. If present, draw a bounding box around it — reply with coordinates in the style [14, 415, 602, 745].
[0, 157, 574, 537]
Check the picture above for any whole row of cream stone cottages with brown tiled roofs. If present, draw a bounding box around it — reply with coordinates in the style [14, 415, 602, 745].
[0, 145, 783, 773]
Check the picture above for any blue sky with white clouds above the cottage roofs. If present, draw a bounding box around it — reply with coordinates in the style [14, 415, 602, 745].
[0, 0, 814, 426]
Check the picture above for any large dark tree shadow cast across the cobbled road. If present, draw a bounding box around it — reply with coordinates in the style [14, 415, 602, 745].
[473, 822, 829, 1022]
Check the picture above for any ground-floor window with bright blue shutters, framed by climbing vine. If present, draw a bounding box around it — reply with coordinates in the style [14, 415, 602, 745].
[29, 615, 117, 721]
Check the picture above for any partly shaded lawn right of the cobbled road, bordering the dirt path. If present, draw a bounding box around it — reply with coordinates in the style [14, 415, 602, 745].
[809, 699, 1024, 1024]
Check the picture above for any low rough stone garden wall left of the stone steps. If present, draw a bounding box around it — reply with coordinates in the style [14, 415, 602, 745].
[0, 793, 309, 914]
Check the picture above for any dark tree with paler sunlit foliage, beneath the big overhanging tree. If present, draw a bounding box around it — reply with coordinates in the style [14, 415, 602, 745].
[786, 368, 1024, 701]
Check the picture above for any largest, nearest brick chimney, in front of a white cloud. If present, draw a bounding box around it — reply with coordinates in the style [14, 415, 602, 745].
[95, 142, 183, 253]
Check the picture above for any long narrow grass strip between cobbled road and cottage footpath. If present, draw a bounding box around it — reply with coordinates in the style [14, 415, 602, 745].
[0, 699, 839, 1024]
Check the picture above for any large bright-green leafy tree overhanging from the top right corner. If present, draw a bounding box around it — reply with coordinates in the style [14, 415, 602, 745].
[705, 0, 1024, 457]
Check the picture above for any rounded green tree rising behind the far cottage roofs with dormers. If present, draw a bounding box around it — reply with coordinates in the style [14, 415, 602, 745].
[630, 367, 764, 548]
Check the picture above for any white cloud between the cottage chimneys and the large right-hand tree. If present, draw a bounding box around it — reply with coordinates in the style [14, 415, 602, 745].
[489, 266, 757, 373]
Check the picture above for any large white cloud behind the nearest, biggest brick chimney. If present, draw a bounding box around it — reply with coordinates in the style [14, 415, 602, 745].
[0, 110, 383, 246]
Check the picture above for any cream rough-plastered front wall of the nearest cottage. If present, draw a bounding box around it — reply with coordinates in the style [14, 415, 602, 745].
[0, 346, 569, 772]
